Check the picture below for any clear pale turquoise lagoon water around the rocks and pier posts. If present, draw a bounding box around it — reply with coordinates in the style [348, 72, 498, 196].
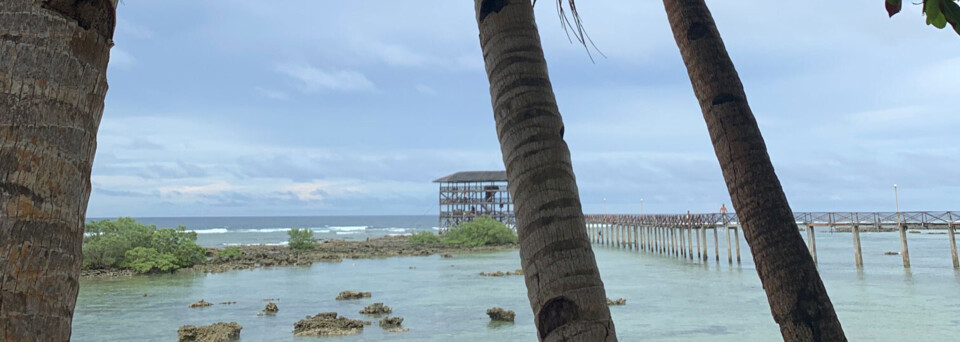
[73, 224, 960, 341]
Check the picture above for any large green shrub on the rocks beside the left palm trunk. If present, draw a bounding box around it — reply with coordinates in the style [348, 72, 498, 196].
[83, 217, 206, 273]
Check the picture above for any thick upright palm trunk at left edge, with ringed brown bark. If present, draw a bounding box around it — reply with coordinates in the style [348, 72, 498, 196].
[0, 0, 117, 342]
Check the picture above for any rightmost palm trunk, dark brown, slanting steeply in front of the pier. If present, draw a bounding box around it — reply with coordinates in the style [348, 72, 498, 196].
[664, 0, 846, 341]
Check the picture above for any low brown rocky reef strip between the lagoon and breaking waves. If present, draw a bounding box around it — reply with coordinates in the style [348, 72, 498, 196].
[80, 236, 517, 278]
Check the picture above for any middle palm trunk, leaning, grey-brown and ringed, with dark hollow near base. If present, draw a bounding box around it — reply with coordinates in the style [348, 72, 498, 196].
[475, 0, 616, 341]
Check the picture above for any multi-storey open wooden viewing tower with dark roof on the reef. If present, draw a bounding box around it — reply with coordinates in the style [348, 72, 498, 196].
[433, 171, 516, 230]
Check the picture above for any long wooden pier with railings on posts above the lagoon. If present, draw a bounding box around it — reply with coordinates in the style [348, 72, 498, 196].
[585, 211, 960, 269]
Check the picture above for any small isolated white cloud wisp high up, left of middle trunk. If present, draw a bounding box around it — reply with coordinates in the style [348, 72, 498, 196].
[277, 63, 374, 93]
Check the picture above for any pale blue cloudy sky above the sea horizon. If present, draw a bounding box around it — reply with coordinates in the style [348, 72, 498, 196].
[87, 0, 960, 217]
